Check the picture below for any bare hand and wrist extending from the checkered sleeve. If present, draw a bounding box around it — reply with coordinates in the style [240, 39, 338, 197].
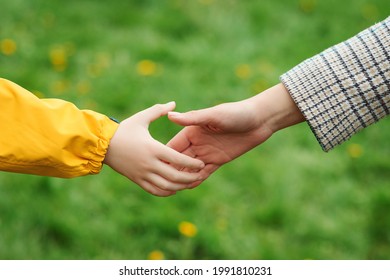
[167, 84, 304, 187]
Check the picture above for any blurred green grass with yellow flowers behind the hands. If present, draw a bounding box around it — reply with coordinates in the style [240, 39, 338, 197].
[0, 0, 390, 259]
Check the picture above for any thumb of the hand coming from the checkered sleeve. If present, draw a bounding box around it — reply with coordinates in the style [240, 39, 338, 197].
[168, 108, 214, 126]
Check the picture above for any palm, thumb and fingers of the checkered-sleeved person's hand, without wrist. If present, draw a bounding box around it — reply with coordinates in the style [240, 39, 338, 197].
[167, 101, 272, 187]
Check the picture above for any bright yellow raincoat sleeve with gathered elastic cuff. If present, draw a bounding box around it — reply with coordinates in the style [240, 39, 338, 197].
[0, 79, 118, 178]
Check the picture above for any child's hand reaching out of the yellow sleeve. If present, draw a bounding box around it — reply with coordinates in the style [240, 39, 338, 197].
[104, 102, 204, 196]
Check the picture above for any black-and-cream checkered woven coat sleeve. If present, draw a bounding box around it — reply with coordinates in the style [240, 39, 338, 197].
[280, 17, 390, 151]
